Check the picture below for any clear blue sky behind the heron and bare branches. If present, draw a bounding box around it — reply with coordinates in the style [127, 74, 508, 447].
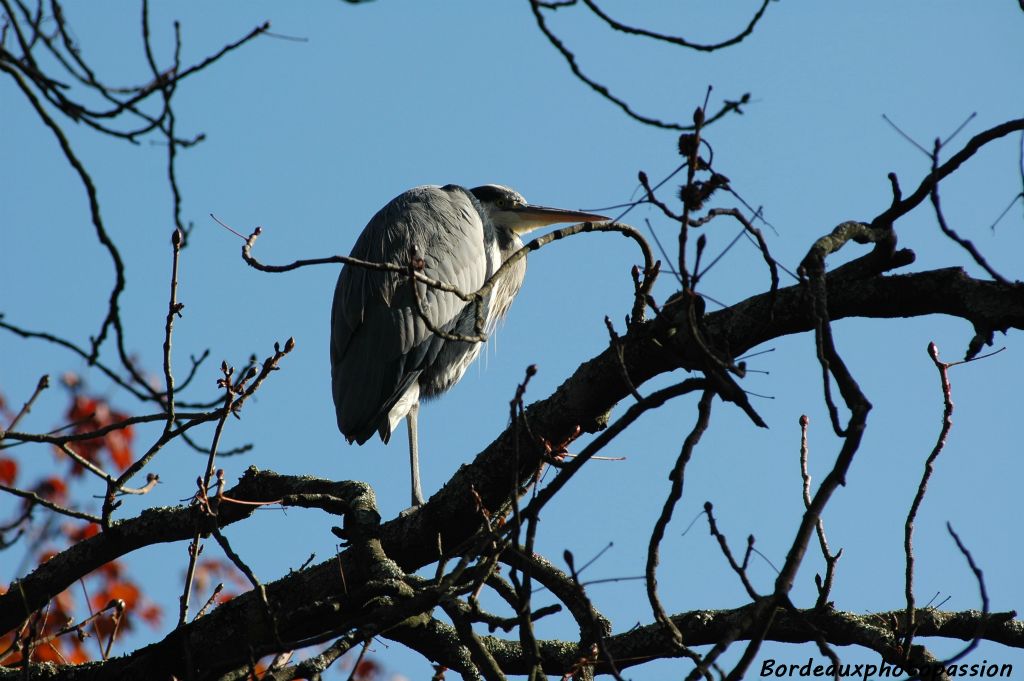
[0, 0, 1024, 679]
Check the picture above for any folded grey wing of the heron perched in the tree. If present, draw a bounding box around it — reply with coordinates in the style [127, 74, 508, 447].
[331, 185, 490, 443]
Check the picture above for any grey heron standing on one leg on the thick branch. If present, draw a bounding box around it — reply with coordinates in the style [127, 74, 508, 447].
[331, 184, 607, 507]
